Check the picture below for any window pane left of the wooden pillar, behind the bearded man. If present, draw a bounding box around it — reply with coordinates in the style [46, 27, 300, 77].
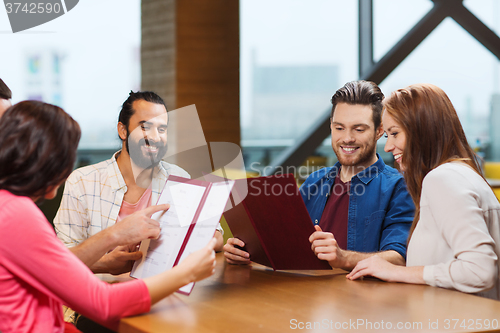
[0, 0, 141, 150]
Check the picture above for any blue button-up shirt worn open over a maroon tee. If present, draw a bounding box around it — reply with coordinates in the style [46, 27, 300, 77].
[300, 154, 415, 258]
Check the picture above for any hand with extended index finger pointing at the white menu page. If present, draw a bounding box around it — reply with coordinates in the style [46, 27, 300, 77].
[110, 201, 170, 245]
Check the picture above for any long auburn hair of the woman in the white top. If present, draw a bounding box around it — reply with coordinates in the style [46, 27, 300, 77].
[384, 83, 482, 237]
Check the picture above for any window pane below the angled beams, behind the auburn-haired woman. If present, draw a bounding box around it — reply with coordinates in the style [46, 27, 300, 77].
[380, 18, 500, 159]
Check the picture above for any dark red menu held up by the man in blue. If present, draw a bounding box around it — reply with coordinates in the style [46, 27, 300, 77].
[224, 174, 331, 270]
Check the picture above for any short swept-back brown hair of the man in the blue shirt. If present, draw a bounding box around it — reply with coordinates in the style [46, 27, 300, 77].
[331, 80, 384, 129]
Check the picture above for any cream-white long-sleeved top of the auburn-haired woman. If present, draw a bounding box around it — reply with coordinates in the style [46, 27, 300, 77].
[407, 162, 500, 300]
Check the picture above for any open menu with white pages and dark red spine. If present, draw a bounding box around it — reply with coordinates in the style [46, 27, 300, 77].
[130, 176, 234, 295]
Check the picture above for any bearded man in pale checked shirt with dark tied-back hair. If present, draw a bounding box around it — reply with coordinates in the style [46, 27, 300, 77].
[54, 91, 222, 274]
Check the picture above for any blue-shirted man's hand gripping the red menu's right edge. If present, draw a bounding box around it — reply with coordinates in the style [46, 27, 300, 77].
[309, 225, 347, 268]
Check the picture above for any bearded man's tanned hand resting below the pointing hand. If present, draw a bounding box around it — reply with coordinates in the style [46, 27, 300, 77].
[99, 245, 142, 275]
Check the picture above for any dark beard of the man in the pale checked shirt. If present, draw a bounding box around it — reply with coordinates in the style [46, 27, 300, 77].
[125, 130, 168, 169]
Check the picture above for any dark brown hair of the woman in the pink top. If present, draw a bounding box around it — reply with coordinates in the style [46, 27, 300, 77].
[0, 101, 81, 198]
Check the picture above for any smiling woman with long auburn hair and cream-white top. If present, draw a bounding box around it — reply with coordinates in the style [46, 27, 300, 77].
[347, 84, 500, 300]
